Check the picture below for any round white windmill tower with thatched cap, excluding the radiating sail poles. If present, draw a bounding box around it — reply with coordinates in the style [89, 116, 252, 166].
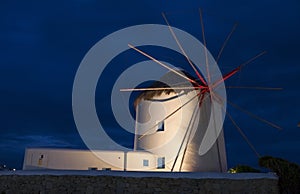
[135, 71, 227, 172]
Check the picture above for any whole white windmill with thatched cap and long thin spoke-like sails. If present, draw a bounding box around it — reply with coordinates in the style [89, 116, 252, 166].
[121, 10, 281, 172]
